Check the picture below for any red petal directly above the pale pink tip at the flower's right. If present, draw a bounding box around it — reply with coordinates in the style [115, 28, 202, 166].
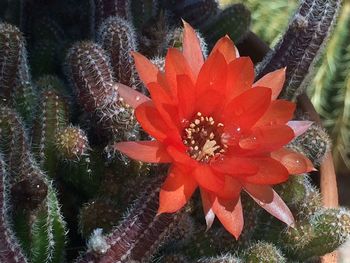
[254, 100, 296, 127]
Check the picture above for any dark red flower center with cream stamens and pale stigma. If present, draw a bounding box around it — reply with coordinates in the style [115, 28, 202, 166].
[182, 112, 228, 163]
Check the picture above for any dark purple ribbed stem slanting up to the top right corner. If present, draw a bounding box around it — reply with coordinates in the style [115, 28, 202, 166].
[257, 0, 341, 99]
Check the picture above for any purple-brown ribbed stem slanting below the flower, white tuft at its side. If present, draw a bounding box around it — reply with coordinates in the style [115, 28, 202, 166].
[77, 174, 186, 263]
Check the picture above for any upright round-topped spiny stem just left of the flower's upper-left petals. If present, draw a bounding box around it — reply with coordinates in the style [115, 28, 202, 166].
[98, 17, 138, 86]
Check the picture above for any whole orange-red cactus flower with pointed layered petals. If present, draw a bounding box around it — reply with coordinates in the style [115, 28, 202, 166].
[115, 22, 313, 238]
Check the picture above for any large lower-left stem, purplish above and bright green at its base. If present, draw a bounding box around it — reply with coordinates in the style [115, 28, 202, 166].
[0, 107, 65, 263]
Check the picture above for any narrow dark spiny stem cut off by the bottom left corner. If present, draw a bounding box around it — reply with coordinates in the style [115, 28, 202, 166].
[0, 156, 28, 263]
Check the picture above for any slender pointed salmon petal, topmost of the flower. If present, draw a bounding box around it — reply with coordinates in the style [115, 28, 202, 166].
[182, 20, 204, 76]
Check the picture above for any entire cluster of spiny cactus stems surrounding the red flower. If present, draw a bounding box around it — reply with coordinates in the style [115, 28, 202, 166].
[0, 0, 350, 263]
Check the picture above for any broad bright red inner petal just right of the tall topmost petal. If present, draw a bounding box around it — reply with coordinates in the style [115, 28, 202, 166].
[196, 51, 227, 97]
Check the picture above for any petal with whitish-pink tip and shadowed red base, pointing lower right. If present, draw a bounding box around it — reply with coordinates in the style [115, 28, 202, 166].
[245, 185, 295, 229]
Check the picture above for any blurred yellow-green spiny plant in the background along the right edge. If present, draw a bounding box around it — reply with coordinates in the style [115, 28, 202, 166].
[311, 2, 350, 174]
